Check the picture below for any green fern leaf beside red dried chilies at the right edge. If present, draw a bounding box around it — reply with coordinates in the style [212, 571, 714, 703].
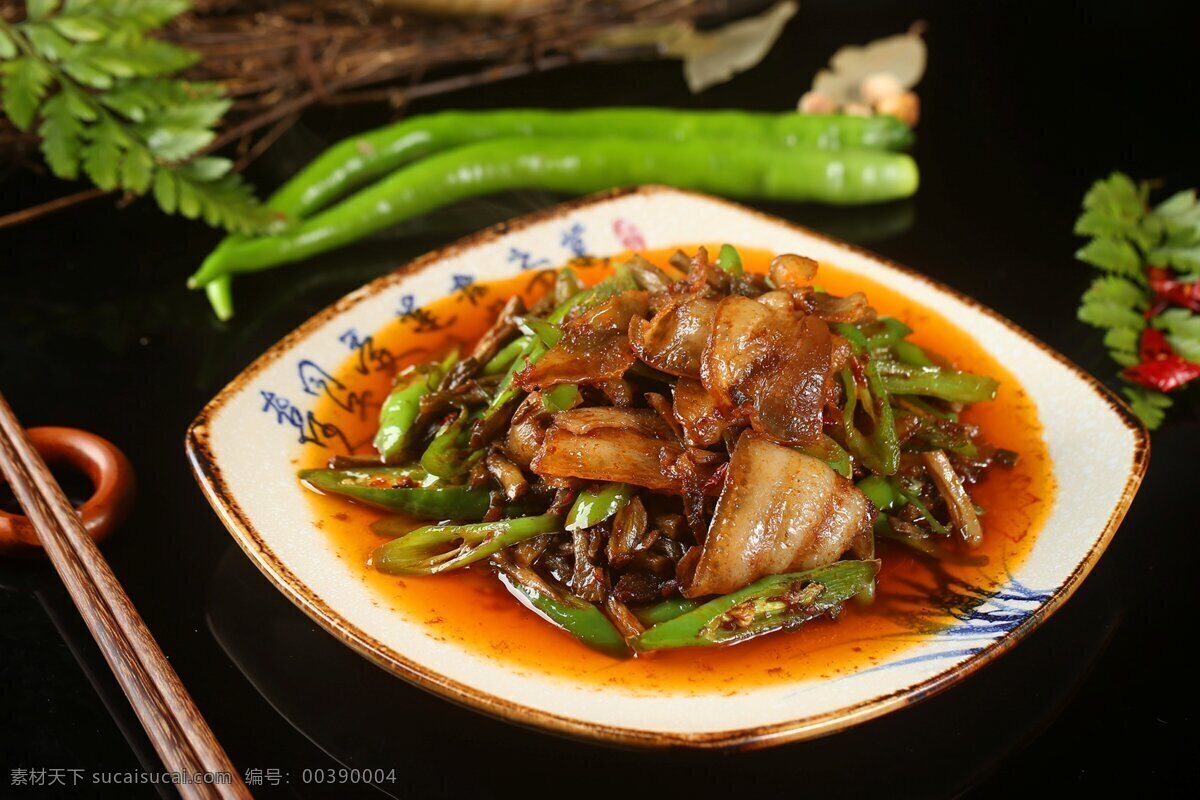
[1075, 173, 1200, 428]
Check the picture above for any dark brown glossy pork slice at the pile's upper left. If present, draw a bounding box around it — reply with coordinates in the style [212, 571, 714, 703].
[516, 291, 649, 390]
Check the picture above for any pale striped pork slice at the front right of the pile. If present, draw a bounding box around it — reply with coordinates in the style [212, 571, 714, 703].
[680, 431, 874, 597]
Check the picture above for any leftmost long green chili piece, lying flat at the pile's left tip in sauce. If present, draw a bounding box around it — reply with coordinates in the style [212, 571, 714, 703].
[300, 469, 490, 519]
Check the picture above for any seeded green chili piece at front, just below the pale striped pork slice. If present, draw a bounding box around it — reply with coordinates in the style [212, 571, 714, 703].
[634, 561, 880, 650]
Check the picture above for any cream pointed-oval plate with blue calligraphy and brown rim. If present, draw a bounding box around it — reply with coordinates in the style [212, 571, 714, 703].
[187, 186, 1148, 747]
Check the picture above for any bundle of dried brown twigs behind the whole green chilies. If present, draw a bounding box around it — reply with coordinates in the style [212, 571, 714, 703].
[0, 0, 769, 227]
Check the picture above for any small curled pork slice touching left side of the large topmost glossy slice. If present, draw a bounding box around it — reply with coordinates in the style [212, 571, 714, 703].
[629, 297, 719, 378]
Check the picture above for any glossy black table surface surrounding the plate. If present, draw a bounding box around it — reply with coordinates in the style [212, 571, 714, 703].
[0, 0, 1200, 798]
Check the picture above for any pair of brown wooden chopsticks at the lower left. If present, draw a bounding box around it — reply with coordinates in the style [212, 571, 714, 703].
[0, 393, 251, 800]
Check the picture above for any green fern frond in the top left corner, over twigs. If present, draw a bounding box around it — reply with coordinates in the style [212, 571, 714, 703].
[0, 0, 269, 233]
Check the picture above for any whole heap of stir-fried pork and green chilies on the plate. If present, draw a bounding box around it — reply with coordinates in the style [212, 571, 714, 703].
[300, 246, 1016, 655]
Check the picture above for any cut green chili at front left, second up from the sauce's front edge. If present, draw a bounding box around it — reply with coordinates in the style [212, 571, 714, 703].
[371, 513, 562, 575]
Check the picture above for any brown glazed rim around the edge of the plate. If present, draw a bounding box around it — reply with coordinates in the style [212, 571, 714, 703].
[186, 186, 1150, 750]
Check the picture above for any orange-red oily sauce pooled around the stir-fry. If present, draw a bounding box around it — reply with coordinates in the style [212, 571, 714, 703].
[302, 246, 1055, 692]
